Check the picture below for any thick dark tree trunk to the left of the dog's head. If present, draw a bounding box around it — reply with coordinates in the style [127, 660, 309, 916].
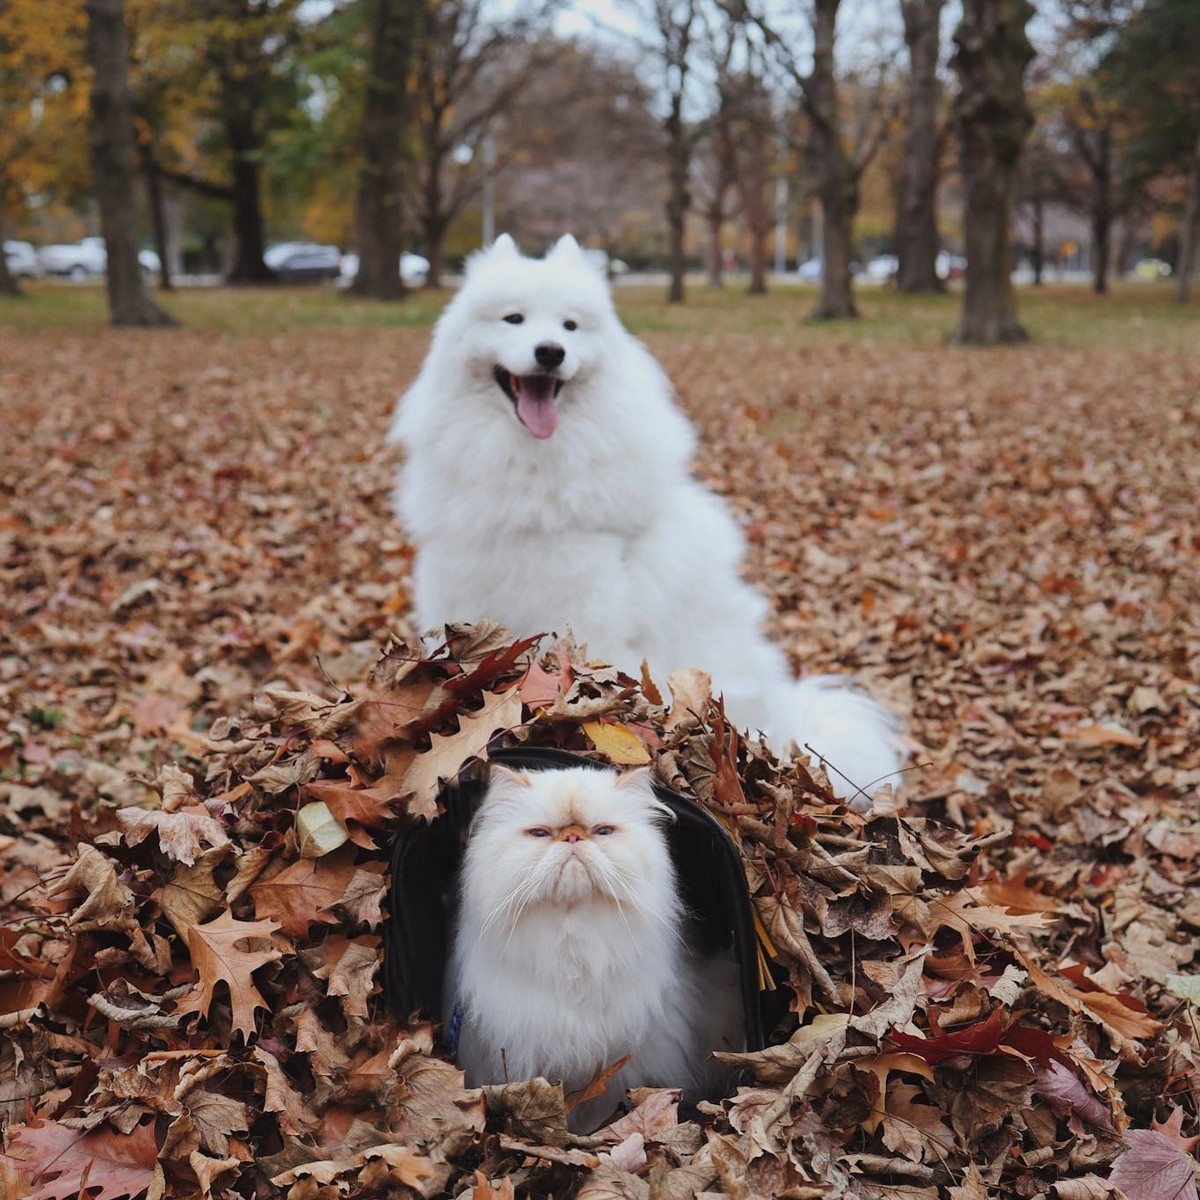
[350, 0, 417, 300]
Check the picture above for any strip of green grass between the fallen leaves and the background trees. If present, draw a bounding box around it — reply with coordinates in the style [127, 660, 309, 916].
[0, 272, 1200, 353]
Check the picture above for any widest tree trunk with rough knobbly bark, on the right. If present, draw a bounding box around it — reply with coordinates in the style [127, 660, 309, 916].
[954, 0, 1033, 346]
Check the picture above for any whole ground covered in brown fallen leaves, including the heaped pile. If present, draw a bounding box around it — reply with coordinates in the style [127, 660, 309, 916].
[0, 312, 1200, 1200]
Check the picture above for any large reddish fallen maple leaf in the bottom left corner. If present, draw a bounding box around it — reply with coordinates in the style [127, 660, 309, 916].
[8, 1121, 158, 1200]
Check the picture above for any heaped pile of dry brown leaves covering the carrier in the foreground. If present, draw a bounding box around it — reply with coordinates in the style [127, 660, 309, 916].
[0, 626, 1200, 1200]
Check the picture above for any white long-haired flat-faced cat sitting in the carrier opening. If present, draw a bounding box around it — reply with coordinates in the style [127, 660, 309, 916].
[446, 767, 744, 1132]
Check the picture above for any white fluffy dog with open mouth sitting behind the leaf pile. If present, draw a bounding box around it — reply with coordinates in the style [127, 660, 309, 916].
[392, 235, 900, 794]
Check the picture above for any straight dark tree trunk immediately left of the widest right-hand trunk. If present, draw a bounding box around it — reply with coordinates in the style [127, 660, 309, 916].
[896, 0, 946, 292]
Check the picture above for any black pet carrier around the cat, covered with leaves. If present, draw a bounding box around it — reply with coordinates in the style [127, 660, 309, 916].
[383, 746, 784, 1050]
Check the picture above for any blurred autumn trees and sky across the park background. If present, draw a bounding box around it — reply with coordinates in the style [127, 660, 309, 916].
[0, 0, 1200, 340]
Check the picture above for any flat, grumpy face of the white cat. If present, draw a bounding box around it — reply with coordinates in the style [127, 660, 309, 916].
[464, 767, 674, 929]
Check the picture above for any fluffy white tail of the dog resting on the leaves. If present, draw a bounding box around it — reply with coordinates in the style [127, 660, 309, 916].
[788, 674, 904, 809]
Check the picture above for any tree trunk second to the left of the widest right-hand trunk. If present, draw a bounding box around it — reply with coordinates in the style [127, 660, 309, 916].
[804, 0, 858, 320]
